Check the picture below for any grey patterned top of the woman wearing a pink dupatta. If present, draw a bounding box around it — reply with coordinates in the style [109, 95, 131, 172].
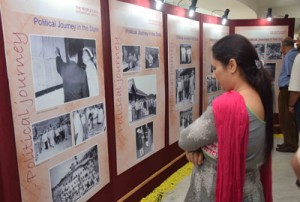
[179, 106, 266, 202]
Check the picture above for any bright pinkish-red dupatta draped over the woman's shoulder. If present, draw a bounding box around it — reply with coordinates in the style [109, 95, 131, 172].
[212, 91, 272, 202]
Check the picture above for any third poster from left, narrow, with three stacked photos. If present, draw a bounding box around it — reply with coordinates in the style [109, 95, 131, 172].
[167, 15, 201, 145]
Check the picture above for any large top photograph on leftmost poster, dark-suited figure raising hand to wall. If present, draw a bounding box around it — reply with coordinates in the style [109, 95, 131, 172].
[30, 35, 99, 111]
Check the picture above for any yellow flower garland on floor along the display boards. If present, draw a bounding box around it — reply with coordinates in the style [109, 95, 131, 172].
[141, 163, 193, 202]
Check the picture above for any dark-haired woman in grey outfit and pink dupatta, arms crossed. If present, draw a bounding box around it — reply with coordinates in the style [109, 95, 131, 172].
[179, 35, 273, 202]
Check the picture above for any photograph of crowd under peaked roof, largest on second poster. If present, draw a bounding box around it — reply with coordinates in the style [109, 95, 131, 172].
[128, 74, 157, 123]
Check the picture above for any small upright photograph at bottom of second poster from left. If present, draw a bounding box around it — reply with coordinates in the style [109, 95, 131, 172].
[135, 122, 153, 158]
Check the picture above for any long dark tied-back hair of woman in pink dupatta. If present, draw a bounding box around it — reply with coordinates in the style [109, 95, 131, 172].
[212, 34, 273, 154]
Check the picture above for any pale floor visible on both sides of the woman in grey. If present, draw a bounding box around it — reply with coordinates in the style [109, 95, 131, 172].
[162, 138, 300, 202]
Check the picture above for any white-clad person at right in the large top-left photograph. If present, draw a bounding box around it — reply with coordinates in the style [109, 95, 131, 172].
[82, 47, 99, 97]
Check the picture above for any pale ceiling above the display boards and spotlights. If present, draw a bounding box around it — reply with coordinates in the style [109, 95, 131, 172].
[165, 0, 300, 34]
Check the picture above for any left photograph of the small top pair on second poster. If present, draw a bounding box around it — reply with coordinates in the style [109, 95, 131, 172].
[122, 46, 141, 72]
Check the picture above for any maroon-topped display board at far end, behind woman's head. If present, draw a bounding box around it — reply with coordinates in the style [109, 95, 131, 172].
[230, 18, 295, 133]
